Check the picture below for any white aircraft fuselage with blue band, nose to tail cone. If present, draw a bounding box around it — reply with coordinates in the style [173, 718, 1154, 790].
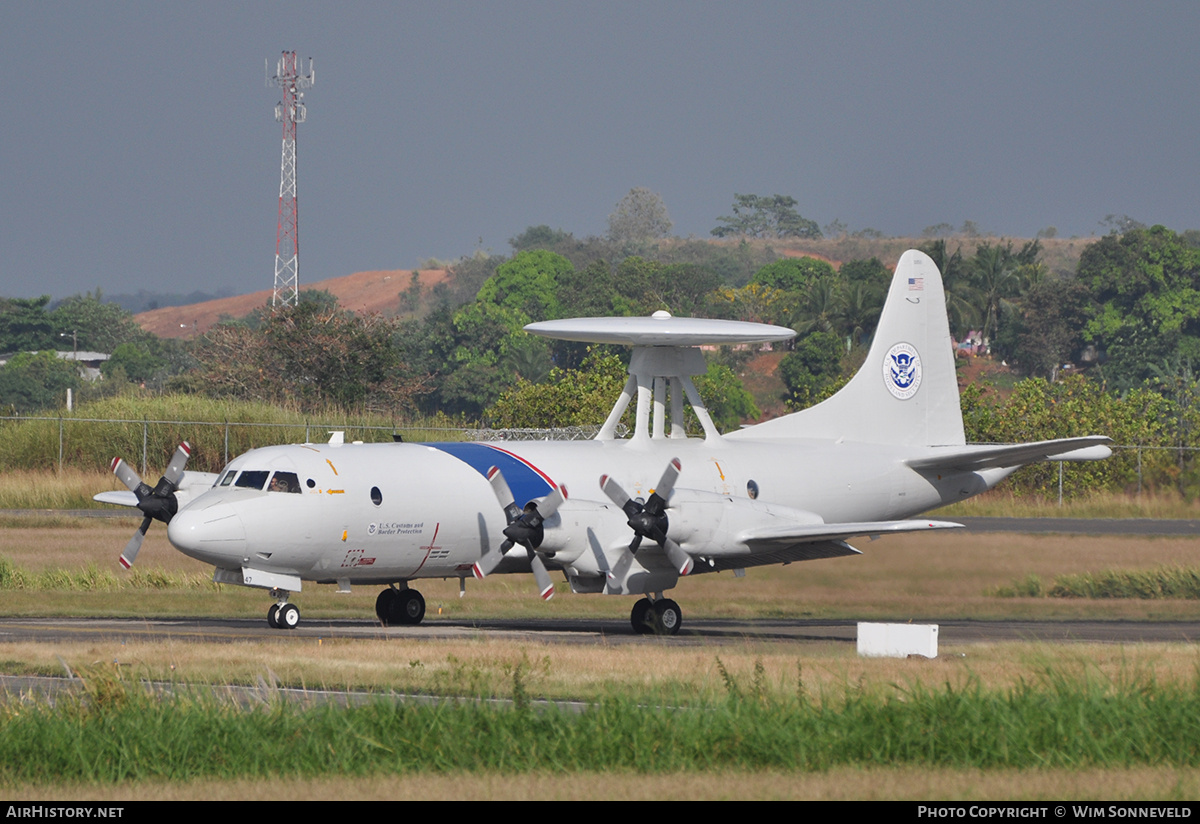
[169, 439, 998, 593]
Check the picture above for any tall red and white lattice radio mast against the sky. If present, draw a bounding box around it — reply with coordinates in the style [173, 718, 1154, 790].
[264, 52, 316, 309]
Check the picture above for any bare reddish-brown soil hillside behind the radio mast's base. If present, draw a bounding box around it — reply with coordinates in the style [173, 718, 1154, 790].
[134, 269, 446, 337]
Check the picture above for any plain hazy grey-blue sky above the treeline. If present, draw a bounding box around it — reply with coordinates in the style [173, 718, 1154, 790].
[0, 0, 1200, 297]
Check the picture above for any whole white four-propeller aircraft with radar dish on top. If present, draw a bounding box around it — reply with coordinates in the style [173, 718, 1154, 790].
[97, 251, 1110, 634]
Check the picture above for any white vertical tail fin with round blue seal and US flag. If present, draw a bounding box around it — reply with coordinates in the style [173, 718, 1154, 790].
[726, 249, 966, 446]
